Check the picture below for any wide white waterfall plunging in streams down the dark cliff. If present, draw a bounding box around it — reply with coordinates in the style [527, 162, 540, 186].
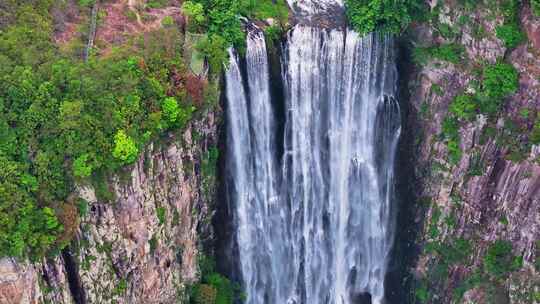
[226, 2, 401, 304]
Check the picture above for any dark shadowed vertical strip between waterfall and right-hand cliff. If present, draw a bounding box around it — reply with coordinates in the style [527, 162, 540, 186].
[385, 36, 422, 304]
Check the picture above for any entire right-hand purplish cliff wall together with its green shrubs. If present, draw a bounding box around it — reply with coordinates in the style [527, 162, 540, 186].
[407, 0, 540, 303]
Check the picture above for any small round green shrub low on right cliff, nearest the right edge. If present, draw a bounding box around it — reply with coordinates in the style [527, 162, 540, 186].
[484, 240, 523, 279]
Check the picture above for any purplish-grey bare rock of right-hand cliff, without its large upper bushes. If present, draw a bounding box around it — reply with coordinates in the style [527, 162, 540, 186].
[407, 1, 540, 304]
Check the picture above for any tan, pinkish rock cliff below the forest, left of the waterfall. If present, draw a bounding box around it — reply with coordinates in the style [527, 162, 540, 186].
[0, 110, 220, 304]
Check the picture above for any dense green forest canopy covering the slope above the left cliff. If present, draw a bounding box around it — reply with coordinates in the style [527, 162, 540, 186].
[0, 0, 200, 259]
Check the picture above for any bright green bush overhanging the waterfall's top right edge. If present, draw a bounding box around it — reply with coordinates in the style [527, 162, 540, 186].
[345, 0, 423, 34]
